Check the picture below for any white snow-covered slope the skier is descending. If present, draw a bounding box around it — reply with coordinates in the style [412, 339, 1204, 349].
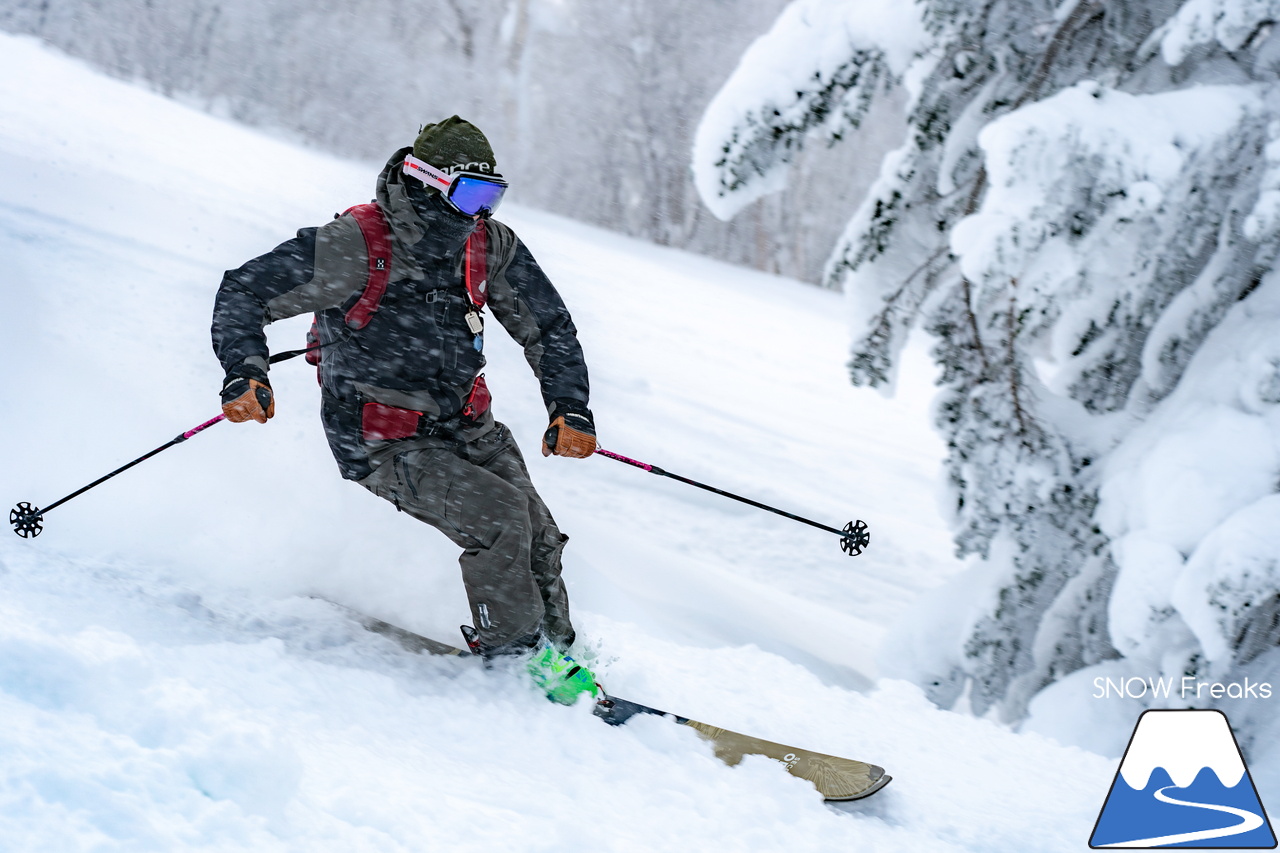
[0, 36, 1177, 852]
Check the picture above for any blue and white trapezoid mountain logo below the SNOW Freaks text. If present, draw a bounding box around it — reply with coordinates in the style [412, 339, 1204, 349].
[1089, 710, 1276, 849]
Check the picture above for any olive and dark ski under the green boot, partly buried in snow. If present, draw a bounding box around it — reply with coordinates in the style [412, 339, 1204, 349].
[330, 602, 892, 802]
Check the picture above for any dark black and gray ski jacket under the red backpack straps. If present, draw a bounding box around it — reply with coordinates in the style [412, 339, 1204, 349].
[212, 149, 589, 479]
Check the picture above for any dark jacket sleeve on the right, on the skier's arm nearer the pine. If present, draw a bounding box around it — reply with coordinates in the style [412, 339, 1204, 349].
[489, 232, 590, 411]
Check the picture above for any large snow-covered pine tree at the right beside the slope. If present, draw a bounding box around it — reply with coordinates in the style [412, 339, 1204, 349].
[694, 0, 1280, 720]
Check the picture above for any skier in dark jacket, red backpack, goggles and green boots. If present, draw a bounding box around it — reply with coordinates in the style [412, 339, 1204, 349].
[212, 115, 596, 703]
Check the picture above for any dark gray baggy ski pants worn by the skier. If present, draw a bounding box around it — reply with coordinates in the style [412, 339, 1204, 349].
[360, 424, 573, 649]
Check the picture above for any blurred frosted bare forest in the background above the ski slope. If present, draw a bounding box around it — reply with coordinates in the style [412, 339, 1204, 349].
[0, 0, 901, 282]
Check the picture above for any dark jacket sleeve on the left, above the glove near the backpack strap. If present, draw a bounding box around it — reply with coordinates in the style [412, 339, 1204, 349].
[211, 216, 366, 370]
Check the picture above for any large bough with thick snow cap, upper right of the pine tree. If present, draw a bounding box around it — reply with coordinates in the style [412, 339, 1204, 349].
[951, 83, 1263, 411]
